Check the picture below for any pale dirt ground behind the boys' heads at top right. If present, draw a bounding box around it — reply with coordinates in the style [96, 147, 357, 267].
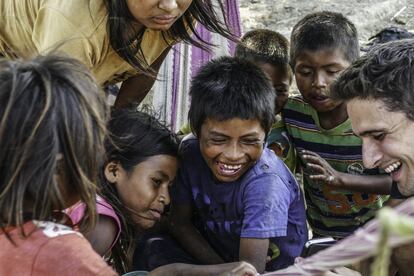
[239, 0, 414, 44]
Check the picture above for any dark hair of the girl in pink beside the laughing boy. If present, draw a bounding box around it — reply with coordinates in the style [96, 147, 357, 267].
[100, 108, 178, 274]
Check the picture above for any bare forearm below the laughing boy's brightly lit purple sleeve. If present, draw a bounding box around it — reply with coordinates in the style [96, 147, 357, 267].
[239, 238, 269, 273]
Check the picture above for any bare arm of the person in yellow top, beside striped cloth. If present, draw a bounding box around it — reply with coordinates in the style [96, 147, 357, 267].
[115, 47, 171, 108]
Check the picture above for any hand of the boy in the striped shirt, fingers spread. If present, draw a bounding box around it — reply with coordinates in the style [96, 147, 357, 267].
[300, 150, 343, 187]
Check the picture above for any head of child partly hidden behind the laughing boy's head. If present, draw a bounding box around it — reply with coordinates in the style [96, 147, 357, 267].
[235, 29, 292, 113]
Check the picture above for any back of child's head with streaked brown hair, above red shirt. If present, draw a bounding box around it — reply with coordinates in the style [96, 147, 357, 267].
[0, 55, 107, 232]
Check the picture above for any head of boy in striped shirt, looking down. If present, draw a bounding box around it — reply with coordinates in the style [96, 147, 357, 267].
[290, 11, 359, 112]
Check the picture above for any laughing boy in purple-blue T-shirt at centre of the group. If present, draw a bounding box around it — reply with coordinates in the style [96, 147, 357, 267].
[170, 57, 307, 272]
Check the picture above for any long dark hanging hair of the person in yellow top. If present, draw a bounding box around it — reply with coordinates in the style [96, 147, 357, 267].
[105, 0, 236, 76]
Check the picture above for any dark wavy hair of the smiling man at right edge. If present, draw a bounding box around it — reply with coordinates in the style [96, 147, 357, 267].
[331, 39, 414, 121]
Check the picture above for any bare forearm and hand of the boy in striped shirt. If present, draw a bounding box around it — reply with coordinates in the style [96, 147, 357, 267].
[301, 150, 392, 194]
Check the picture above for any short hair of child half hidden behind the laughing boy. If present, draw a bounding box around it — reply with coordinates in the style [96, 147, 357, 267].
[234, 29, 289, 70]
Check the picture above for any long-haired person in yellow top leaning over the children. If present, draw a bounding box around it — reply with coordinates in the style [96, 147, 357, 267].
[0, 0, 232, 107]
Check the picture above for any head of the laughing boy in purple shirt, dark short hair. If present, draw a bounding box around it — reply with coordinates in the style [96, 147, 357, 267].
[188, 57, 275, 182]
